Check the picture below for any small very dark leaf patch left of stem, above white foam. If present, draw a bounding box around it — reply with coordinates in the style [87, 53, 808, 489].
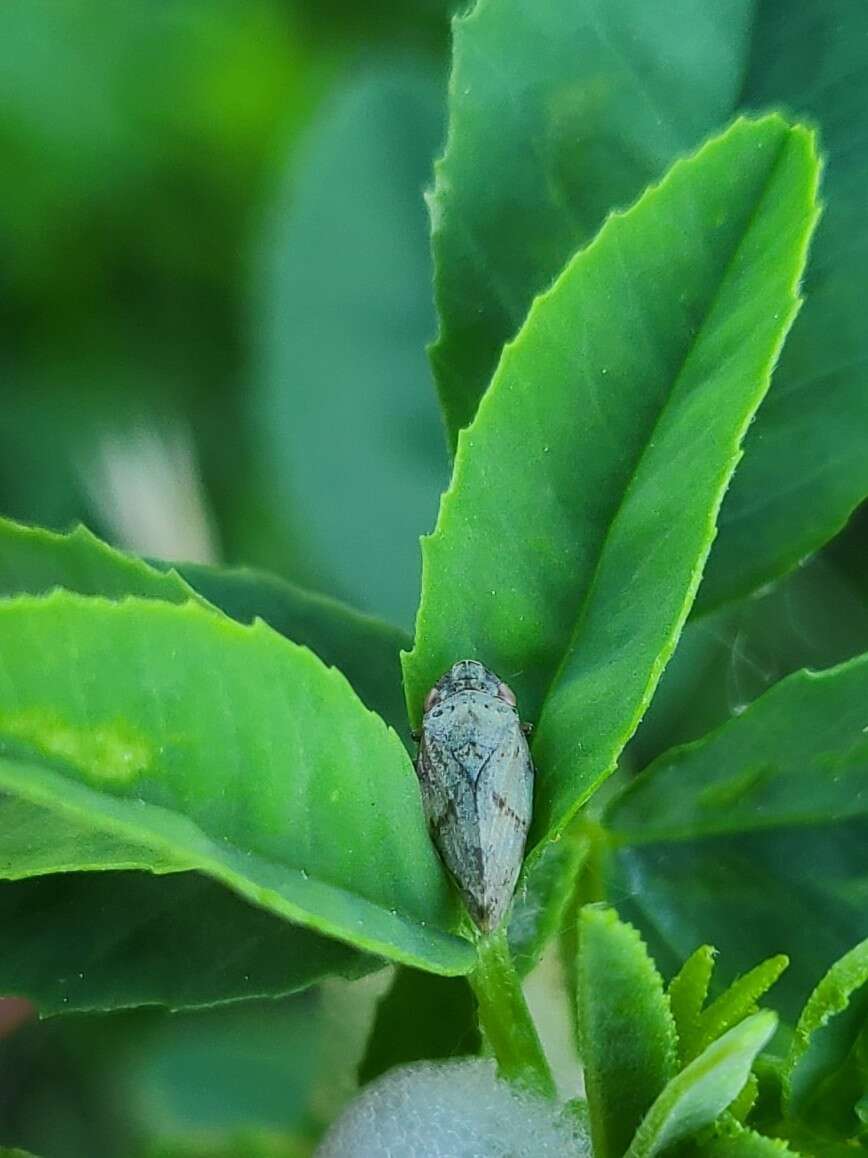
[359, 967, 480, 1084]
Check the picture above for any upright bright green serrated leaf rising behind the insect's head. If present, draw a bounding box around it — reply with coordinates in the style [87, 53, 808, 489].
[404, 116, 818, 843]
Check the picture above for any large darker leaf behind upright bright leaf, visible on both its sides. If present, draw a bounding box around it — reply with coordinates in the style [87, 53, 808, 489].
[432, 0, 868, 610]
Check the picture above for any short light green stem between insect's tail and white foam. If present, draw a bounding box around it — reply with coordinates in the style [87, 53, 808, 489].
[468, 926, 556, 1098]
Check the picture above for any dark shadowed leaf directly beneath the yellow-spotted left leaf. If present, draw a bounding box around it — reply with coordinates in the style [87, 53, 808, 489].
[0, 870, 368, 1017]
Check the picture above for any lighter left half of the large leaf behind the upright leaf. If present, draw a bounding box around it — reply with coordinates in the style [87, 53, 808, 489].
[431, 0, 751, 447]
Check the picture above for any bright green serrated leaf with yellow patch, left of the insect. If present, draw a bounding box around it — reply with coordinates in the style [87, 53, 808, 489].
[0, 593, 475, 1009]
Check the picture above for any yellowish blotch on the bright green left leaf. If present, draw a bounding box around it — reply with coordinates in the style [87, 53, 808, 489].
[0, 709, 152, 785]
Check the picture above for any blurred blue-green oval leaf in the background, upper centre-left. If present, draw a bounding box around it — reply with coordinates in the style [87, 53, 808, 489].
[255, 59, 447, 624]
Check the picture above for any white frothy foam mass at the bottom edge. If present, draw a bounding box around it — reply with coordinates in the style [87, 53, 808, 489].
[316, 1058, 590, 1158]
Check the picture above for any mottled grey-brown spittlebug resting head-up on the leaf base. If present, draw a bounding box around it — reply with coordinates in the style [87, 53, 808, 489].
[415, 659, 534, 932]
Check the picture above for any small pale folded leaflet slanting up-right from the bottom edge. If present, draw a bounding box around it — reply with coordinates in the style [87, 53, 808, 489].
[627, 1012, 778, 1158]
